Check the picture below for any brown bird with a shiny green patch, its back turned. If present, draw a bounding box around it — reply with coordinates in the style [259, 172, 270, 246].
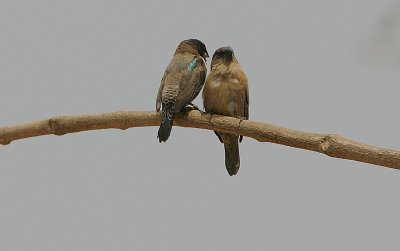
[156, 39, 208, 143]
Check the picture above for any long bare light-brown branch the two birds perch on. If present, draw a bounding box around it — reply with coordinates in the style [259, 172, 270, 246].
[0, 111, 400, 169]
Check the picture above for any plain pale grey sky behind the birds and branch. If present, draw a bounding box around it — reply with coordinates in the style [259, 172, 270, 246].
[0, 0, 400, 251]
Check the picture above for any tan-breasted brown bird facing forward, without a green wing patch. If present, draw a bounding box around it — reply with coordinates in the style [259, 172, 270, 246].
[203, 47, 249, 176]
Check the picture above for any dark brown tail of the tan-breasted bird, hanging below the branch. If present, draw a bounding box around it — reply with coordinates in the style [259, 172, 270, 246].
[223, 134, 240, 176]
